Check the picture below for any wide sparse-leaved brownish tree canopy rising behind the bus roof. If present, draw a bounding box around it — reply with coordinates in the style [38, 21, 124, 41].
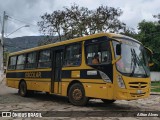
[38, 4, 126, 44]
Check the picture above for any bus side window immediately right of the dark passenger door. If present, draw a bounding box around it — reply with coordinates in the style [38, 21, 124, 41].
[64, 44, 81, 66]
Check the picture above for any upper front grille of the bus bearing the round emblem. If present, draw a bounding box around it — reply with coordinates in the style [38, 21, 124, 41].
[129, 82, 147, 89]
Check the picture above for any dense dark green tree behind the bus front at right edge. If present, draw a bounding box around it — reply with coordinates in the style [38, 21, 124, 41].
[138, 20, 160, 70]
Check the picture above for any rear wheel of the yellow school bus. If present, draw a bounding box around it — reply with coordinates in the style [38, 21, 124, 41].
[18, 81, 27, 97]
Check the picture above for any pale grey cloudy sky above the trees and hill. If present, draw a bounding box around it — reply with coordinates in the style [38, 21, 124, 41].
[0, 0, 160, 38]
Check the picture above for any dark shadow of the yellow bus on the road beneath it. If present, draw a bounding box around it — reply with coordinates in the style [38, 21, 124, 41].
[10, 92, 140, 111]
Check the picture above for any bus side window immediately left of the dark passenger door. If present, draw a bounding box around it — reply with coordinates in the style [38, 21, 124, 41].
[38, 49, 51, 68]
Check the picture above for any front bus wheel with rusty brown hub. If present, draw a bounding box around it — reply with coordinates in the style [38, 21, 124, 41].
[68, 83, 89, 106]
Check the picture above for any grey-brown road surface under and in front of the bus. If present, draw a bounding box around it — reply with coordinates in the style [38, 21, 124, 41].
[0, 79, 160, 120]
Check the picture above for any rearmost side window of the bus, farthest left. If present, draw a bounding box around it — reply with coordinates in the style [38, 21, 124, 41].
[8, 56, 17, 70]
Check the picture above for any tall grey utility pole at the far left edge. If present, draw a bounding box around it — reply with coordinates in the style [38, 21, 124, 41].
[0, 11, 7, 74]
